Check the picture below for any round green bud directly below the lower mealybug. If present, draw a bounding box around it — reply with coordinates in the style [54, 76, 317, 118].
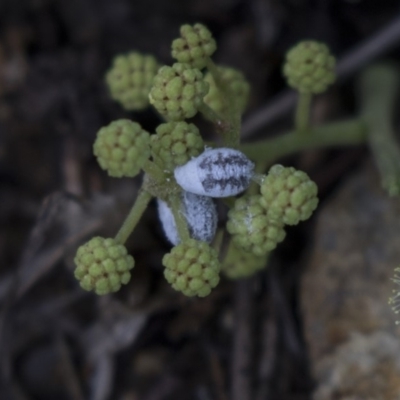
[162, 239, 221, 297]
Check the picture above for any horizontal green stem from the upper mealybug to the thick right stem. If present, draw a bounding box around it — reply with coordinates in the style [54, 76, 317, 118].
[240, 119, 367, 165]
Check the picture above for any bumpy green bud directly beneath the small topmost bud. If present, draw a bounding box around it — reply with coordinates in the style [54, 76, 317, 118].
[149, 63, 208, 121]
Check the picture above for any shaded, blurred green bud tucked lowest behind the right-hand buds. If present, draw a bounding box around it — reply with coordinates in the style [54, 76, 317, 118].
[221, 243, 268, 279]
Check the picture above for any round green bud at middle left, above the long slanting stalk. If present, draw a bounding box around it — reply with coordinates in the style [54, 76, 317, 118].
[93, 119, 150, 178]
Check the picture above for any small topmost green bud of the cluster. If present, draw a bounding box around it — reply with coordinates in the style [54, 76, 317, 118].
[172, 24, 217, 69]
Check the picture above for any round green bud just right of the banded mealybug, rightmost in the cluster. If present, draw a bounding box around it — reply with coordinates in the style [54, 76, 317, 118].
[260, 164, 318, 225]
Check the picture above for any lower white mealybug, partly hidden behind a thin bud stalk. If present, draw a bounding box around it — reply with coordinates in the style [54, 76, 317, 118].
[157, 192, 218, 245]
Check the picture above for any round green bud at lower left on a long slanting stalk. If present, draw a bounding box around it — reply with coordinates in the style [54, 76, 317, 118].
[74, 236, 135, 295]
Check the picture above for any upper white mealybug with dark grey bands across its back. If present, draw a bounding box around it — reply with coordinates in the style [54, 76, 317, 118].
[174, 147, 254, 197]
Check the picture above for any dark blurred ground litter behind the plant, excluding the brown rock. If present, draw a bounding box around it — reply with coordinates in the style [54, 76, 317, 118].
[0, 0, 399, 400]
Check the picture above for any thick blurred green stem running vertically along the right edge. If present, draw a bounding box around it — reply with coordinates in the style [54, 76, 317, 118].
[359, 64, 400, 196]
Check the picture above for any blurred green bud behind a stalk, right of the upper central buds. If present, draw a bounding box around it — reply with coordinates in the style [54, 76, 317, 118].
[204, 66, 250, 115]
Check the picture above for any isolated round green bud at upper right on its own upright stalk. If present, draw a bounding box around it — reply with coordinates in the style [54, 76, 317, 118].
[283, 40, 336, 94]
